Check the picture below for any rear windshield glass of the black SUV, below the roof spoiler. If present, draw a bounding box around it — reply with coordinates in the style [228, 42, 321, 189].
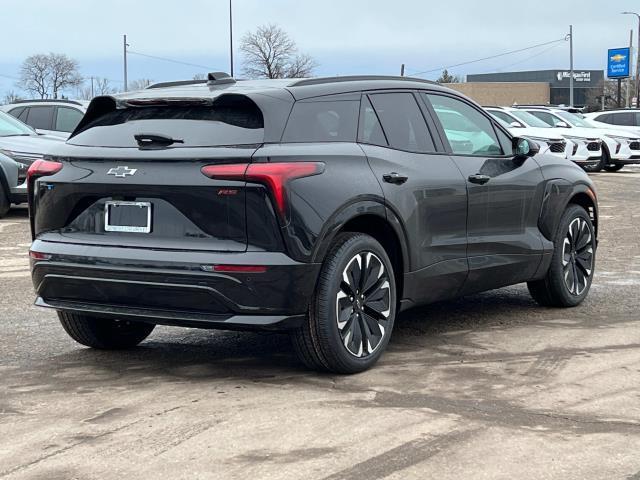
[68, 97, 264, 148]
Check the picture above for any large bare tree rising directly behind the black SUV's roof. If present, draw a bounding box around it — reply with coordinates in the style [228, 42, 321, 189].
[240, 25, 316, 78]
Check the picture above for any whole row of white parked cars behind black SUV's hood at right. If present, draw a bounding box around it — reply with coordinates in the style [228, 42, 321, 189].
[485, 106, 640, 172]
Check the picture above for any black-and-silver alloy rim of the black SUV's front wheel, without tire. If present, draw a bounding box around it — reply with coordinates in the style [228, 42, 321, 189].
[562, 218, 593, 296]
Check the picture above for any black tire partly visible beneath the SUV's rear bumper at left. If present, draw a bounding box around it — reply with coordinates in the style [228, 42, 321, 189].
[58, 312, 155, 350]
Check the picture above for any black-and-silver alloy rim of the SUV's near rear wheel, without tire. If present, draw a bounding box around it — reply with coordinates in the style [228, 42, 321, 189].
[336, 252, 395, 358]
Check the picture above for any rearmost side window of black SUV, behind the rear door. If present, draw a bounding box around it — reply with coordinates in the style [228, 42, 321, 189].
[282, 99, 360, 143]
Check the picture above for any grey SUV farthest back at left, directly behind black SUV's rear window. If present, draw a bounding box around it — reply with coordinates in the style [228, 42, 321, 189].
[0, 100, 89, 140]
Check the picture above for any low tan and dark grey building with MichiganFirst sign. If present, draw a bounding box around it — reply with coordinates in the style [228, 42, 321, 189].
[447, 70, 604, 106]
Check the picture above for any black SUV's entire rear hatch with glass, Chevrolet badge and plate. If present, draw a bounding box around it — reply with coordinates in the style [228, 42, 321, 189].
[33, 95, 264, 252]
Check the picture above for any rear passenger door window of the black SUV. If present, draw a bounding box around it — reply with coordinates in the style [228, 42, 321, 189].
[370, 92, 436, 153]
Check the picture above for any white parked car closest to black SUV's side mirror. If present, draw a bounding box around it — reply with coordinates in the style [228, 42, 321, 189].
[485, 107, 602, 172]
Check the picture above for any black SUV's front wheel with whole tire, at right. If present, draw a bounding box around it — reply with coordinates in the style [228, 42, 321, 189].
[527, 204, 596, 308]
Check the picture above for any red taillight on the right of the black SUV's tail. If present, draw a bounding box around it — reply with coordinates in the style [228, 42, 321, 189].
[202, 162, 324, 216]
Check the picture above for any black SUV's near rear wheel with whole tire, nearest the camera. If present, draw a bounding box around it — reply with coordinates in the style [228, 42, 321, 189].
[292, 233, 396, 374]
